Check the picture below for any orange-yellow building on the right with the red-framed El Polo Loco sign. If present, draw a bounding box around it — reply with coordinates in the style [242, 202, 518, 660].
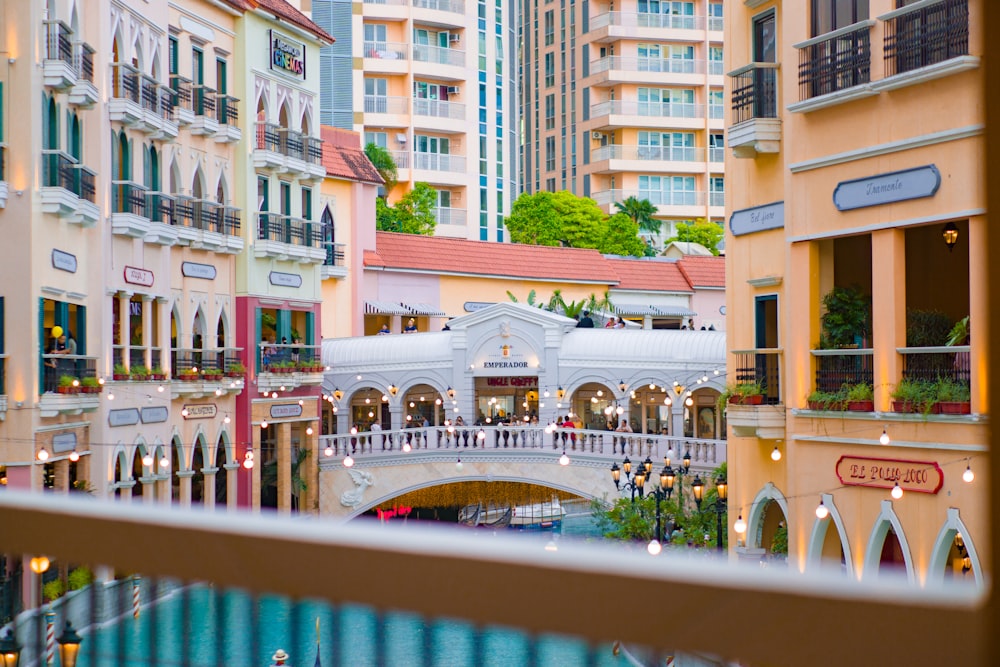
[726, 0, 990, 585]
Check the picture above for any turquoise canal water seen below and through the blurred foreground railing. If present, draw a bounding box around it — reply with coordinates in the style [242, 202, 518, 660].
[77, 586, 621, 667]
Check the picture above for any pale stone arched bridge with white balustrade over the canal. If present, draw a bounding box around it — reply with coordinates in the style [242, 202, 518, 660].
[319, 425, 726, 520]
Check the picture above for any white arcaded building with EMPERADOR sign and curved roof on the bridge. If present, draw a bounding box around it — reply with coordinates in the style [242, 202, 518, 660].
[323, 303, 725, 439]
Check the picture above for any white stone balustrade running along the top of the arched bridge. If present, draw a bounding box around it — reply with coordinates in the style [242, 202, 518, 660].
[320, 426, 726, 472]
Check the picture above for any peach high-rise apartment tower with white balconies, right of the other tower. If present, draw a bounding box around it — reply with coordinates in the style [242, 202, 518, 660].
[519, 0, 725, 246]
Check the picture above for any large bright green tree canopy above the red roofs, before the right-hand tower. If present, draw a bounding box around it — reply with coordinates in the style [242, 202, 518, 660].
[505, 190, 645, 257]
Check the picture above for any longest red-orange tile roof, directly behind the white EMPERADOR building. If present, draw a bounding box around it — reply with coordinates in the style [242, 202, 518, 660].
[365, 232, 618, 285]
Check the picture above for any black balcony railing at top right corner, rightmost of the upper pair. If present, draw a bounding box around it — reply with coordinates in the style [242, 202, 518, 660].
[884, 0, 969, 76]
